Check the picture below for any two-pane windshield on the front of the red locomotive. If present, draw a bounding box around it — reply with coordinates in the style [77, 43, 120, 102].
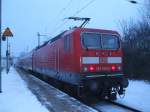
[81, 33, 119, 49]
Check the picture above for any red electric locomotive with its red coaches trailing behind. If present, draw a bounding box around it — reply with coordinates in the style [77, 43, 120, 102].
[19, 17, 128, 98]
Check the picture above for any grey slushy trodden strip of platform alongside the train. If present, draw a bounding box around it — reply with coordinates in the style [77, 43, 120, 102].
[17, 70, 97, 112]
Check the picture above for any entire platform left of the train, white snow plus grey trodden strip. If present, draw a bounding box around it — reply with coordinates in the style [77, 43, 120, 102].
[0, 68, 96, 112]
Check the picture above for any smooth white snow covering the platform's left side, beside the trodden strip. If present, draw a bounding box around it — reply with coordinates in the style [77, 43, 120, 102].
[0, 68, 48, 112]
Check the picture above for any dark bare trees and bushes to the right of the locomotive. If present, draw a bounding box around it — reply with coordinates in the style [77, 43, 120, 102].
[120, 0, 150, 80]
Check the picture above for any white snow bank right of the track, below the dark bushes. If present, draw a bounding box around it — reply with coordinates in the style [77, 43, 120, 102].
[117, 81, 150, 112]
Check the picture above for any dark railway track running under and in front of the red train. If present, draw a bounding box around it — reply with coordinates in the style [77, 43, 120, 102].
[17, 68, 141, 112]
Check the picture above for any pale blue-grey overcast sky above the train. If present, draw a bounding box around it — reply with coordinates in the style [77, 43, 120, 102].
[2, 0, 140, 56]
